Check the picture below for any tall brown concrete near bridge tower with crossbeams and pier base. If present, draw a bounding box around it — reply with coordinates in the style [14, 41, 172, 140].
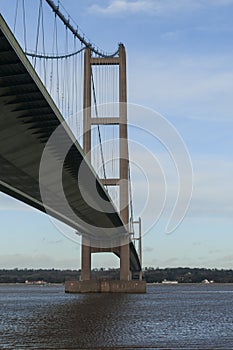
[66, 44, 146, 293]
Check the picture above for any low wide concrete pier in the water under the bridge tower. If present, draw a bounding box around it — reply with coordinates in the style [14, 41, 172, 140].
[65, 280, 146, 294]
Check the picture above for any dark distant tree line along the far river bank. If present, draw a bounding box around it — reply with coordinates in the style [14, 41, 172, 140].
[0, 267, 233, 283]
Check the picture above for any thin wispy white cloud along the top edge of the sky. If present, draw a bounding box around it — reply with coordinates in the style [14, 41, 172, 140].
[89, 0, 233, 16]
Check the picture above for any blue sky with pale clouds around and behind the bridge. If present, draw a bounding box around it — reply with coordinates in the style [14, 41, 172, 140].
[0, 0, 233, 268]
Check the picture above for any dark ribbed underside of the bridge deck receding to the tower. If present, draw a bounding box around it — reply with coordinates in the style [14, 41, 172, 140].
[0, 16, 141, 272]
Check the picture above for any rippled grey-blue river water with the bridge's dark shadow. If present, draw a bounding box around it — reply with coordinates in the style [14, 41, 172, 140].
[0, 284, 233, 349]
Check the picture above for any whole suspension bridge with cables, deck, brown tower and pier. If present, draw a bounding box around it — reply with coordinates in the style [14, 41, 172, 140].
[0, 0, 145, 292]
